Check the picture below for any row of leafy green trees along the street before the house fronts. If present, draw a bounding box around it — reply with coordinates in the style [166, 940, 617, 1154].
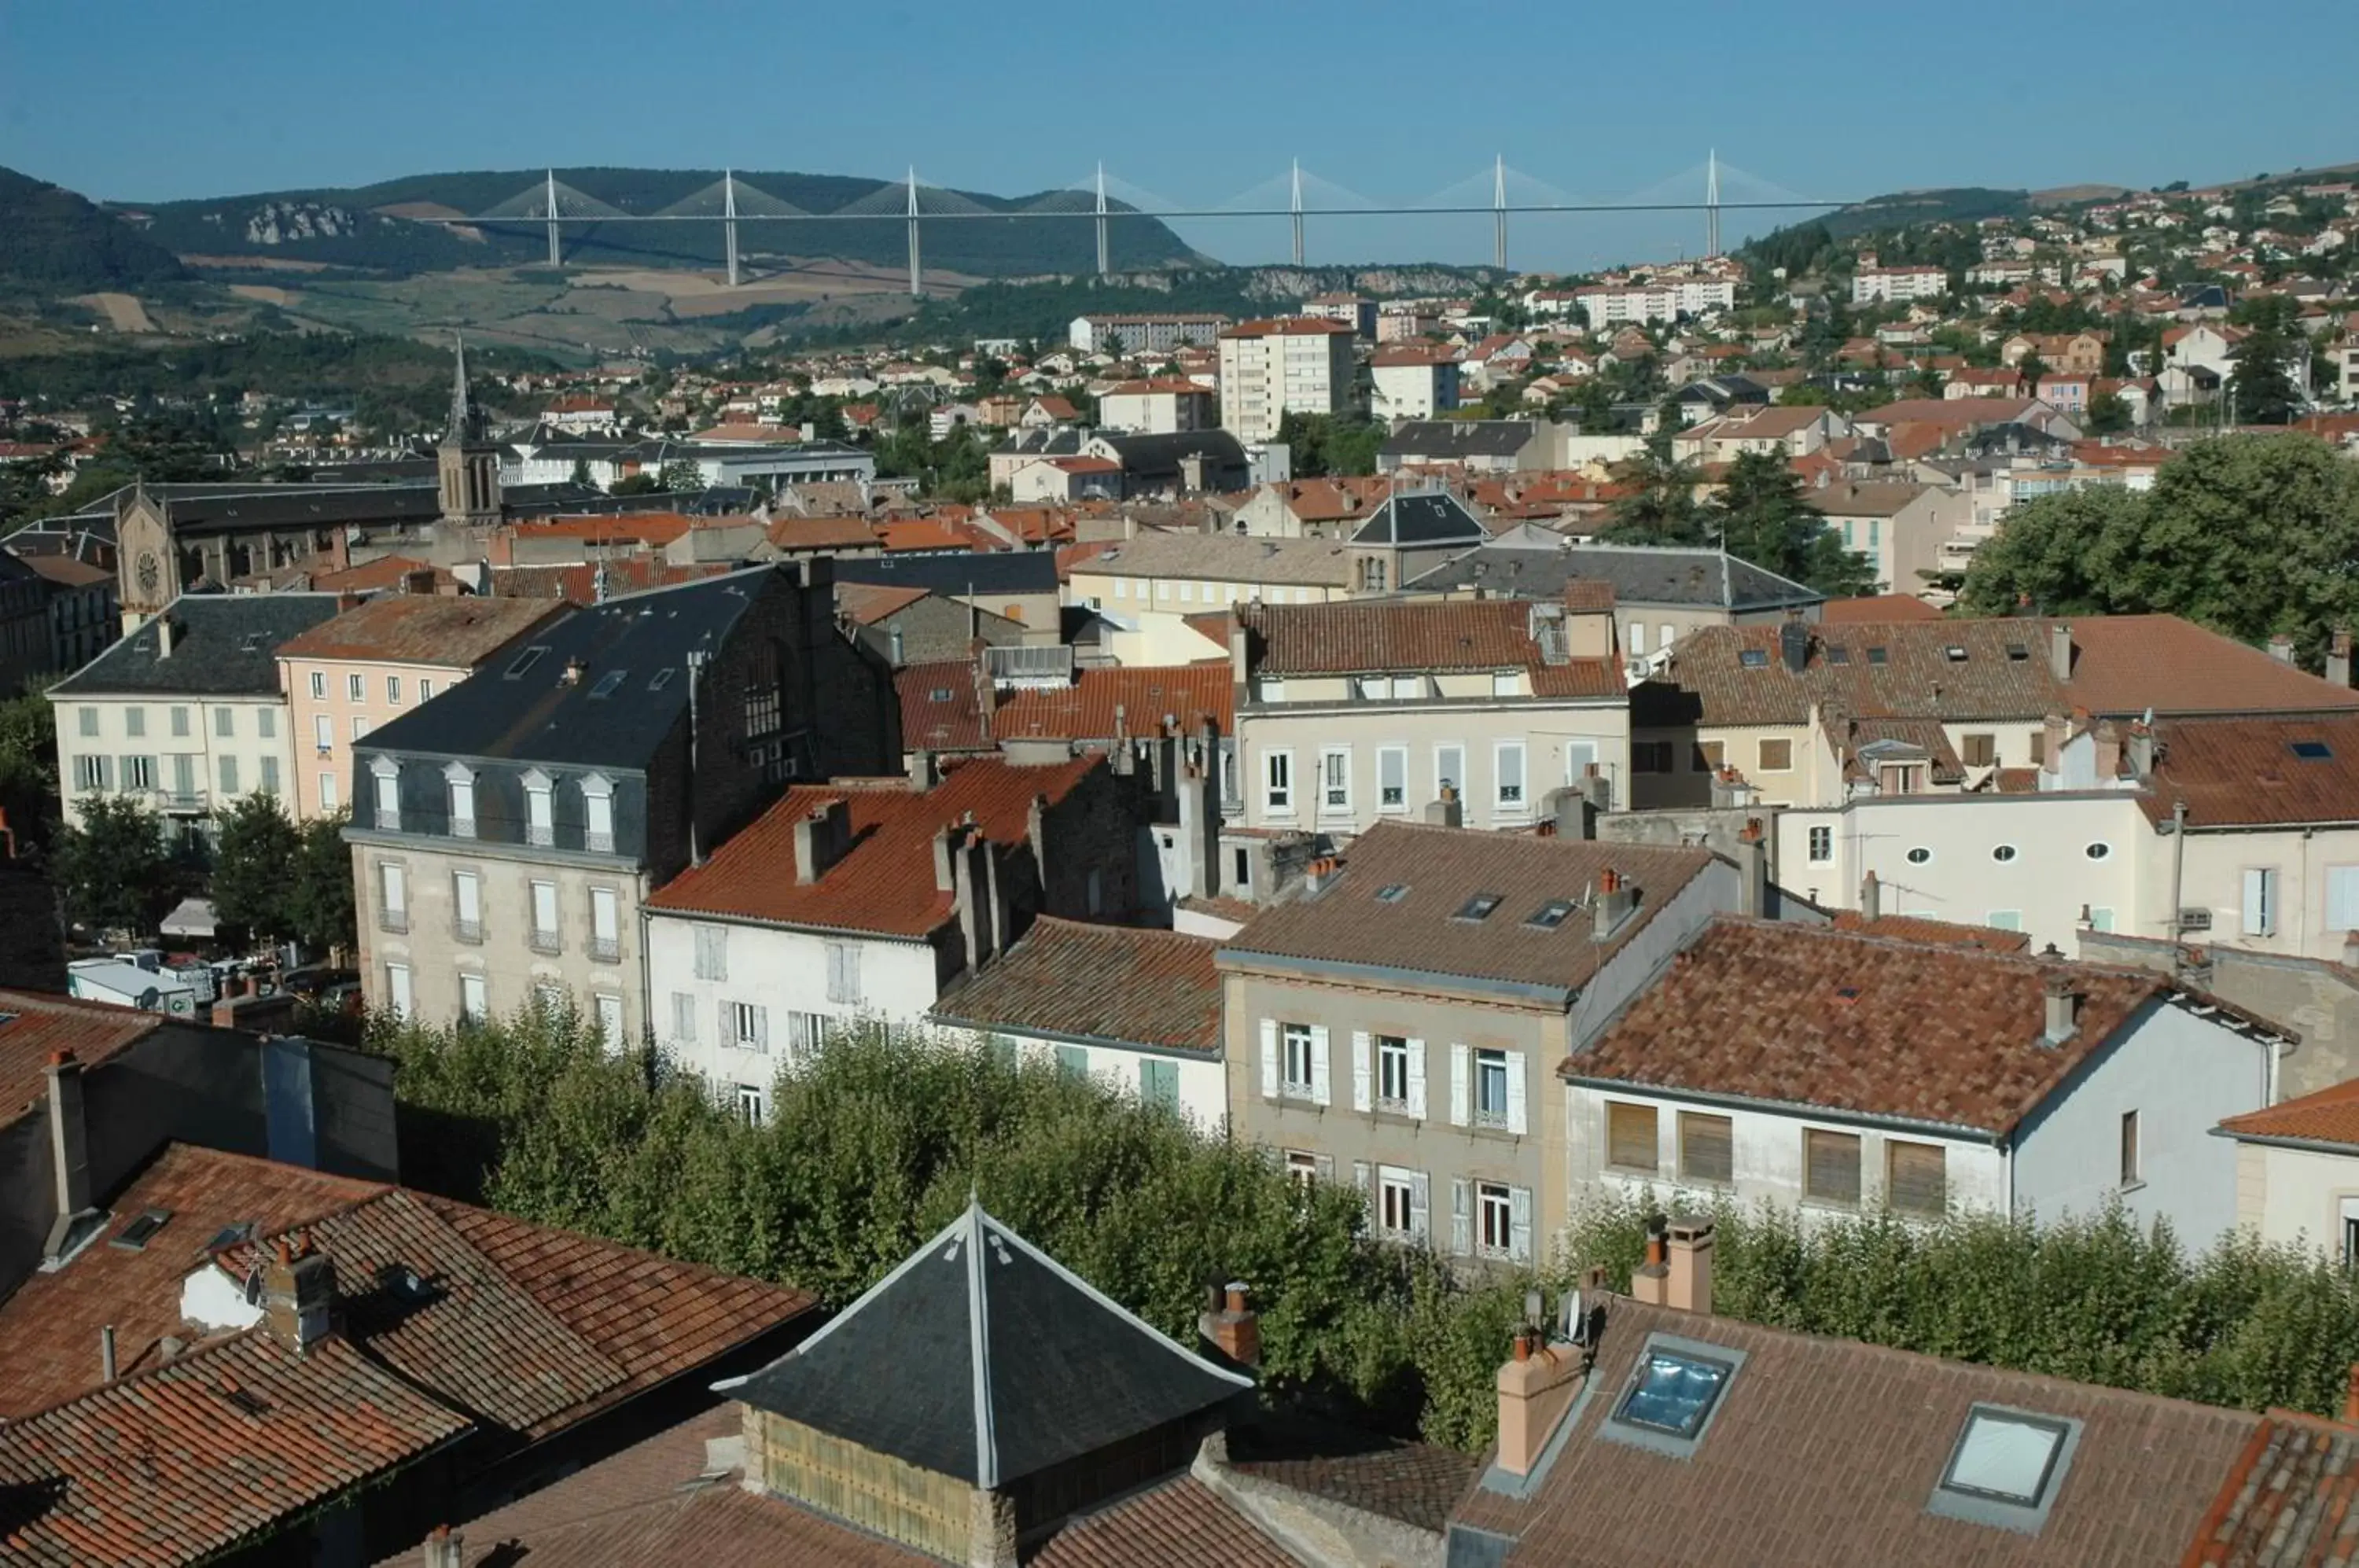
[370, 1011, 2359, 1450]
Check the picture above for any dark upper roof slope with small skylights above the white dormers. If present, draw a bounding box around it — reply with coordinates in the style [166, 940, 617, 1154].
[368, 566, 795, 769]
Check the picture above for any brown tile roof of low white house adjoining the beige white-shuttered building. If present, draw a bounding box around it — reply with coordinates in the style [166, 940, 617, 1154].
[934, 915, 1220, 1054]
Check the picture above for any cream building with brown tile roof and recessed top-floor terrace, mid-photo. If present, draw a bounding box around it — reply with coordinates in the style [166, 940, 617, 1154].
[1229, 592, 1630, 834]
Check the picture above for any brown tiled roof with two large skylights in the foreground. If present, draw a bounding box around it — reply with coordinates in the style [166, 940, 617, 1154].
[1456, 1297, 2265, 1568]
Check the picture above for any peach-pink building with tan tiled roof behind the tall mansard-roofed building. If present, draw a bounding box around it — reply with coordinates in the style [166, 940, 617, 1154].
[278, 594, 564, 818]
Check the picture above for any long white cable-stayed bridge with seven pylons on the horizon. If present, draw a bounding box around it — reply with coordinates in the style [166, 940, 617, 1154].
[418, 151, 1852, 297]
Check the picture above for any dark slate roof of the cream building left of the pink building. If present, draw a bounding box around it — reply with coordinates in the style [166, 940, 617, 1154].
[50, 594, 337, 698]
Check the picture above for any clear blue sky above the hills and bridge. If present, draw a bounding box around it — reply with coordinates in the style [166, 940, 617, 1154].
[0, 0, 2359, 267]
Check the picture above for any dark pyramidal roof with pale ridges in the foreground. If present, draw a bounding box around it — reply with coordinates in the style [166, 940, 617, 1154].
[717, 1200, 1253, 1488]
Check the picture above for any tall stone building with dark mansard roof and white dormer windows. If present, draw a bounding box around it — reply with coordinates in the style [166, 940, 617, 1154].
[344, 561, 901, 1042]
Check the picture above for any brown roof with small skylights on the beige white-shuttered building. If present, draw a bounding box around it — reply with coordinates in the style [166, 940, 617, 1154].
[1217, 823, 1713, 990]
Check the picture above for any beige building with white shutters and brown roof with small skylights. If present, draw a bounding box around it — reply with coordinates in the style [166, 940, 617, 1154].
[1215, 823, 1743, 1264]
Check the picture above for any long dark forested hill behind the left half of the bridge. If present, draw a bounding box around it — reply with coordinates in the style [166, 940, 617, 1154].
[113, 167, 1203, 278]
